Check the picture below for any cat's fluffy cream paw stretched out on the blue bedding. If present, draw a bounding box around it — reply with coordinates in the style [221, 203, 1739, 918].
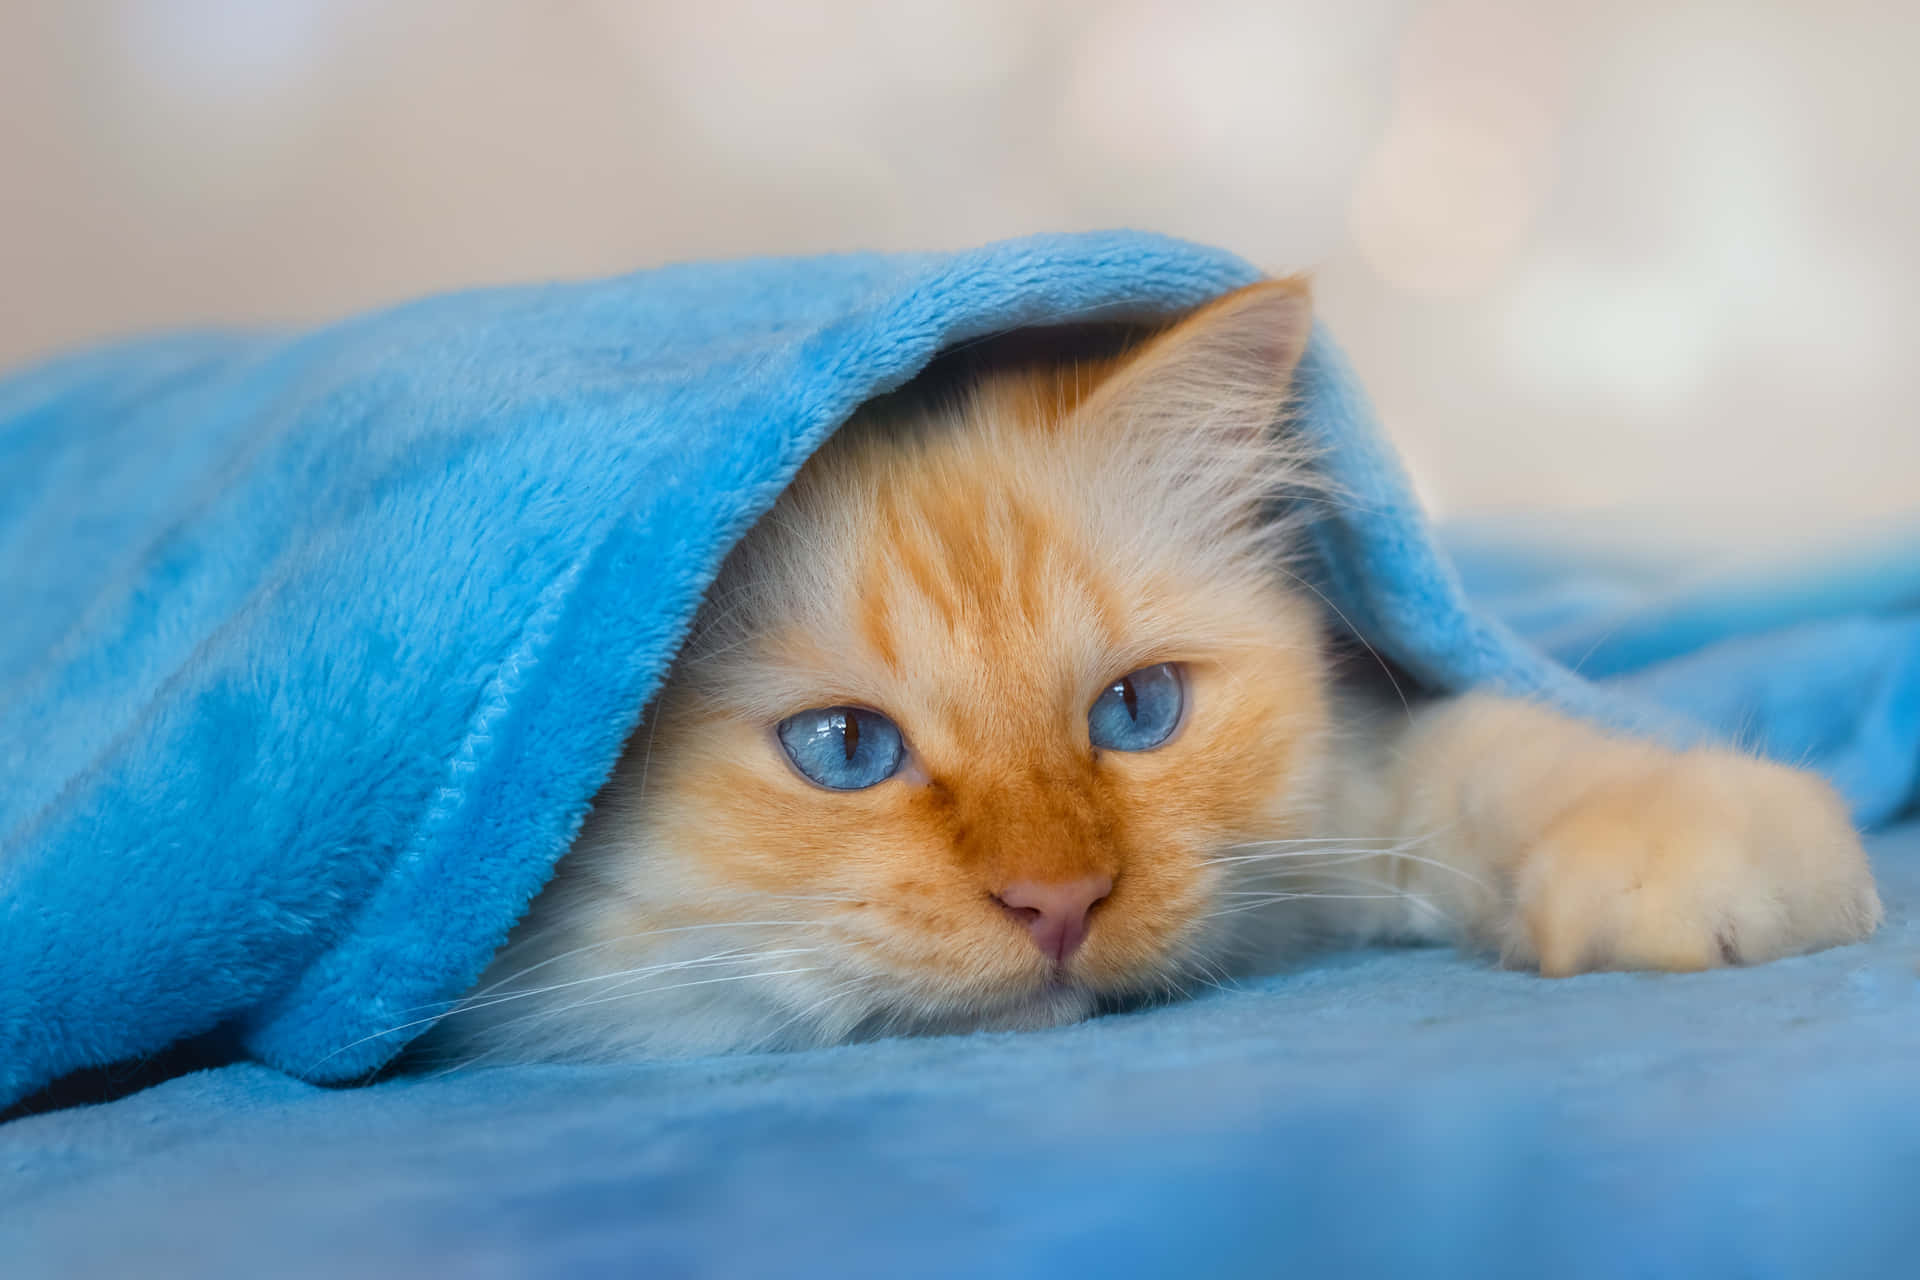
[1500, 750, 1882, 977]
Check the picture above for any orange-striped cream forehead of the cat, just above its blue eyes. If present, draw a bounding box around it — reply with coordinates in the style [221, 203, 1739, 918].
[714, 434, 1246, 733]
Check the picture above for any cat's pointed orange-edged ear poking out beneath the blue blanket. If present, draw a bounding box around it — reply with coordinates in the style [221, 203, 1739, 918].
[1081, 276, 1313, 439]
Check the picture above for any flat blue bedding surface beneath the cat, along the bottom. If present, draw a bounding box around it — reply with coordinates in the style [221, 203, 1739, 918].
[0, 825, 1920, 1280]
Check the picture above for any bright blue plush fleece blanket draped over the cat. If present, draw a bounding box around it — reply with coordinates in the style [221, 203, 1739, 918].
[0, 234, 1920, 1105]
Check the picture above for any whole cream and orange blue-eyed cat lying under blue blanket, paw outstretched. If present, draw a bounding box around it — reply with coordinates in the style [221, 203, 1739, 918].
[426, 278, 1880, 1059]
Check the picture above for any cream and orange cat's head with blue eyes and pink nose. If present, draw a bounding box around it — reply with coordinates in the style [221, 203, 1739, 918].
[470, 280, 1327, 1050]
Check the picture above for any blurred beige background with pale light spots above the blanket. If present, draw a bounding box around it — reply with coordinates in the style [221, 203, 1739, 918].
[0, 0, 1920, 545]
